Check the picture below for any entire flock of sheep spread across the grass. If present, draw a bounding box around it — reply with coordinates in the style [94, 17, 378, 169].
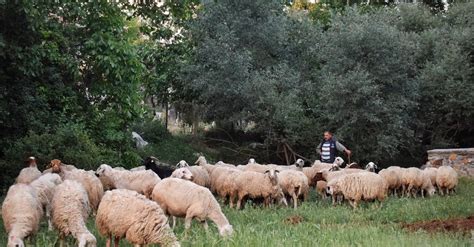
[2, 156, 458, 247]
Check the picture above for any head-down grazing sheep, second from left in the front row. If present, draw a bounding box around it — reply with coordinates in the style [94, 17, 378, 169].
[51, 179, 97, 247]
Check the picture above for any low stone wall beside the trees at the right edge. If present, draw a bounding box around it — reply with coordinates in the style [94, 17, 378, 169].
[427, 148, 474, 176]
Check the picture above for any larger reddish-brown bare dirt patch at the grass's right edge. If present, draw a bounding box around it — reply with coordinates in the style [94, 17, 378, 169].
[402, 215, 474, 236]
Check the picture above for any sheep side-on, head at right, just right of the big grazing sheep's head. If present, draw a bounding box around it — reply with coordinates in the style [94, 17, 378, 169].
[235, 169, 288, 209]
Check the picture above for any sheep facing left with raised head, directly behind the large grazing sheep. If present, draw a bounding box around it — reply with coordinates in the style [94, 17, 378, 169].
[96, 164, 161, 198]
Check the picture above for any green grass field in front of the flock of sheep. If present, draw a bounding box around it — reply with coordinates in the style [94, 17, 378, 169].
[0, 179, 474, 246]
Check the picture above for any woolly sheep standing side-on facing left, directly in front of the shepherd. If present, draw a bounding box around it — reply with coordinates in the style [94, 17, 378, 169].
[327, 172, 387, 209]
